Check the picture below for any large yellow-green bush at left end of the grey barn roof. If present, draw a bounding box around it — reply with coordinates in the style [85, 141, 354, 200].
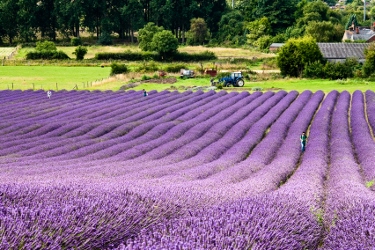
[277, 36, 323, 76]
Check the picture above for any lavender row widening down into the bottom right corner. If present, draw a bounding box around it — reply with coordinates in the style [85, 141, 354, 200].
[322, 92, 375, 249]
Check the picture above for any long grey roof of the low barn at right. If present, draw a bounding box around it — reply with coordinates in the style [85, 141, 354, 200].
[318, 43, 369, 60]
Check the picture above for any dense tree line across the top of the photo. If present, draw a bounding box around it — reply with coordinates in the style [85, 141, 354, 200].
[0, 0, 375, 49]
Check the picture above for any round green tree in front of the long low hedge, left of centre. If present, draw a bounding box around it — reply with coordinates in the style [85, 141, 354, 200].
[151, 30, 178, 59]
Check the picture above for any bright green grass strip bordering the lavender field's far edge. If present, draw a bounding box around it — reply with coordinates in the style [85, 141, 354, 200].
[0, 66, 375, 92]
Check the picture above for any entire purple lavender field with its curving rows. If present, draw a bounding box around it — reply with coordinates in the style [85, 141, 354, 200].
[0, 91, 375, 250]
